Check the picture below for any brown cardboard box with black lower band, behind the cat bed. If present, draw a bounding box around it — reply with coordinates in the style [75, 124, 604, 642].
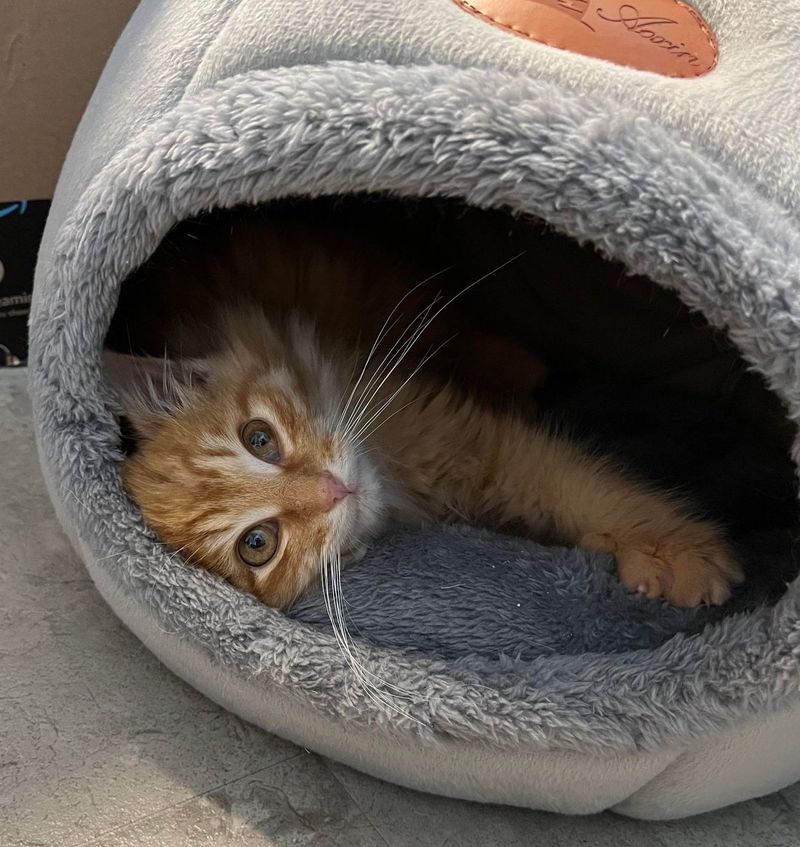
[0, 0, 137, 366]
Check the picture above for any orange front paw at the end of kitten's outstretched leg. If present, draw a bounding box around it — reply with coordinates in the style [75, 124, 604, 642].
[587, 519, 744, 607]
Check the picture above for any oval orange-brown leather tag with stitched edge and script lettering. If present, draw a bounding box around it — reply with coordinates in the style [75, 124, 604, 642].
[454, 0, 719, 77]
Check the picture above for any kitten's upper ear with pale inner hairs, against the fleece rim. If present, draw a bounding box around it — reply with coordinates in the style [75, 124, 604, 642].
[103, 350, 209, 438]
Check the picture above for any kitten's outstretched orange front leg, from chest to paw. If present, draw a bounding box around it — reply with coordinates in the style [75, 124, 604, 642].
[379, 380, 742, 606]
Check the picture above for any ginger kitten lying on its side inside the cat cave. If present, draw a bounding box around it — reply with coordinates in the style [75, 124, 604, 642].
[108, 300, 742, 607]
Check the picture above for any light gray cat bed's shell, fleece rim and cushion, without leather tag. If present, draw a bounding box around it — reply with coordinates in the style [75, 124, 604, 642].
[30, 0, 800, 818]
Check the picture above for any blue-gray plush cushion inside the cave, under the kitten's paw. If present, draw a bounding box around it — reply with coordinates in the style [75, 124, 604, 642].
[289, 526, 722, 664]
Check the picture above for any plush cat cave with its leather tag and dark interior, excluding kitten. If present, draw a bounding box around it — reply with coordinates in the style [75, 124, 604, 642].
[30, 0, 800, 818]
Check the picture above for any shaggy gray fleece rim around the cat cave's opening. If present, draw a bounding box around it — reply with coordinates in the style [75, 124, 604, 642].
[31, 63, 800, 751]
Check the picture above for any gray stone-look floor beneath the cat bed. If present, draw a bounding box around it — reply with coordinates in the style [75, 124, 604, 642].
[0, 370, 800, 847]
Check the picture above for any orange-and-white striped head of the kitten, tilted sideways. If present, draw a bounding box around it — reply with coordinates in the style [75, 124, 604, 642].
[107, 310, 385, 607]
